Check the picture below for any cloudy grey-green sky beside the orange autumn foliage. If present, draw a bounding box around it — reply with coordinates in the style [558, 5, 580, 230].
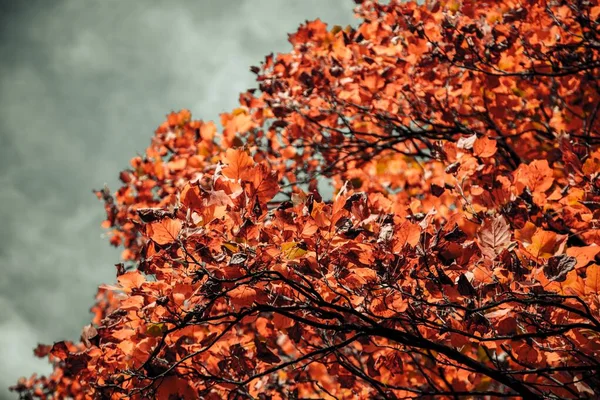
[0, 0, 355, 399]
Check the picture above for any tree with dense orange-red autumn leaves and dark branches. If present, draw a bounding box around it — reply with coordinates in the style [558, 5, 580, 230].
[13, 0, 600, 399]
